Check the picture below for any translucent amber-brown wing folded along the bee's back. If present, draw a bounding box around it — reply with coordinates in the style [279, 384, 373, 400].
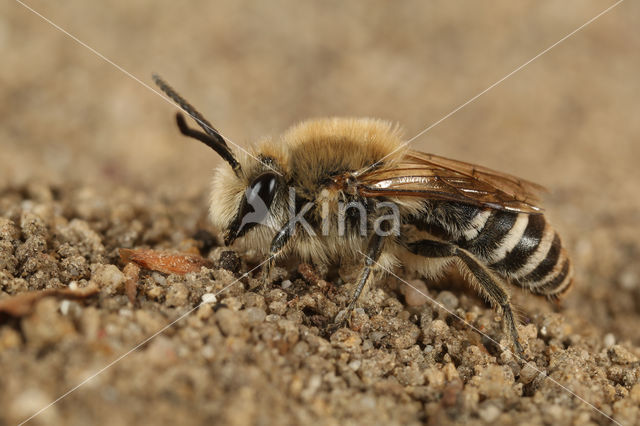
[358, 151, 544, 213]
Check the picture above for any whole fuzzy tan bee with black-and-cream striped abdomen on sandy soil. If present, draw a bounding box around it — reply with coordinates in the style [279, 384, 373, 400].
[154, 76, 573, 355]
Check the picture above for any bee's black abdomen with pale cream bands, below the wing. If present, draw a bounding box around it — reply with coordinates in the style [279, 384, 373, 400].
[456, 209, 572, 297]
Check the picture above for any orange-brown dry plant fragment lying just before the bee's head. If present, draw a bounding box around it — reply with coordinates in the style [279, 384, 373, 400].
[119, 249, 211, 275]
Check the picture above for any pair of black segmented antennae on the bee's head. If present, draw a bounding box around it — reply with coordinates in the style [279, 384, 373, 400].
[153, 74, 240, 175]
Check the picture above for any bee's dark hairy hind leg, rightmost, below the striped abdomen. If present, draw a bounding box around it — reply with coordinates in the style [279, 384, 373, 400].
[407, 240, 524, 359]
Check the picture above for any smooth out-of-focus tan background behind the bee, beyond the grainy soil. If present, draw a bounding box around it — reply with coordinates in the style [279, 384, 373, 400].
[0, 0, 640, 336]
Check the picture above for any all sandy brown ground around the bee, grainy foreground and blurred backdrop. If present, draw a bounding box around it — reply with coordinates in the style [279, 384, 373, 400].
[0, 0, 640, 425]
